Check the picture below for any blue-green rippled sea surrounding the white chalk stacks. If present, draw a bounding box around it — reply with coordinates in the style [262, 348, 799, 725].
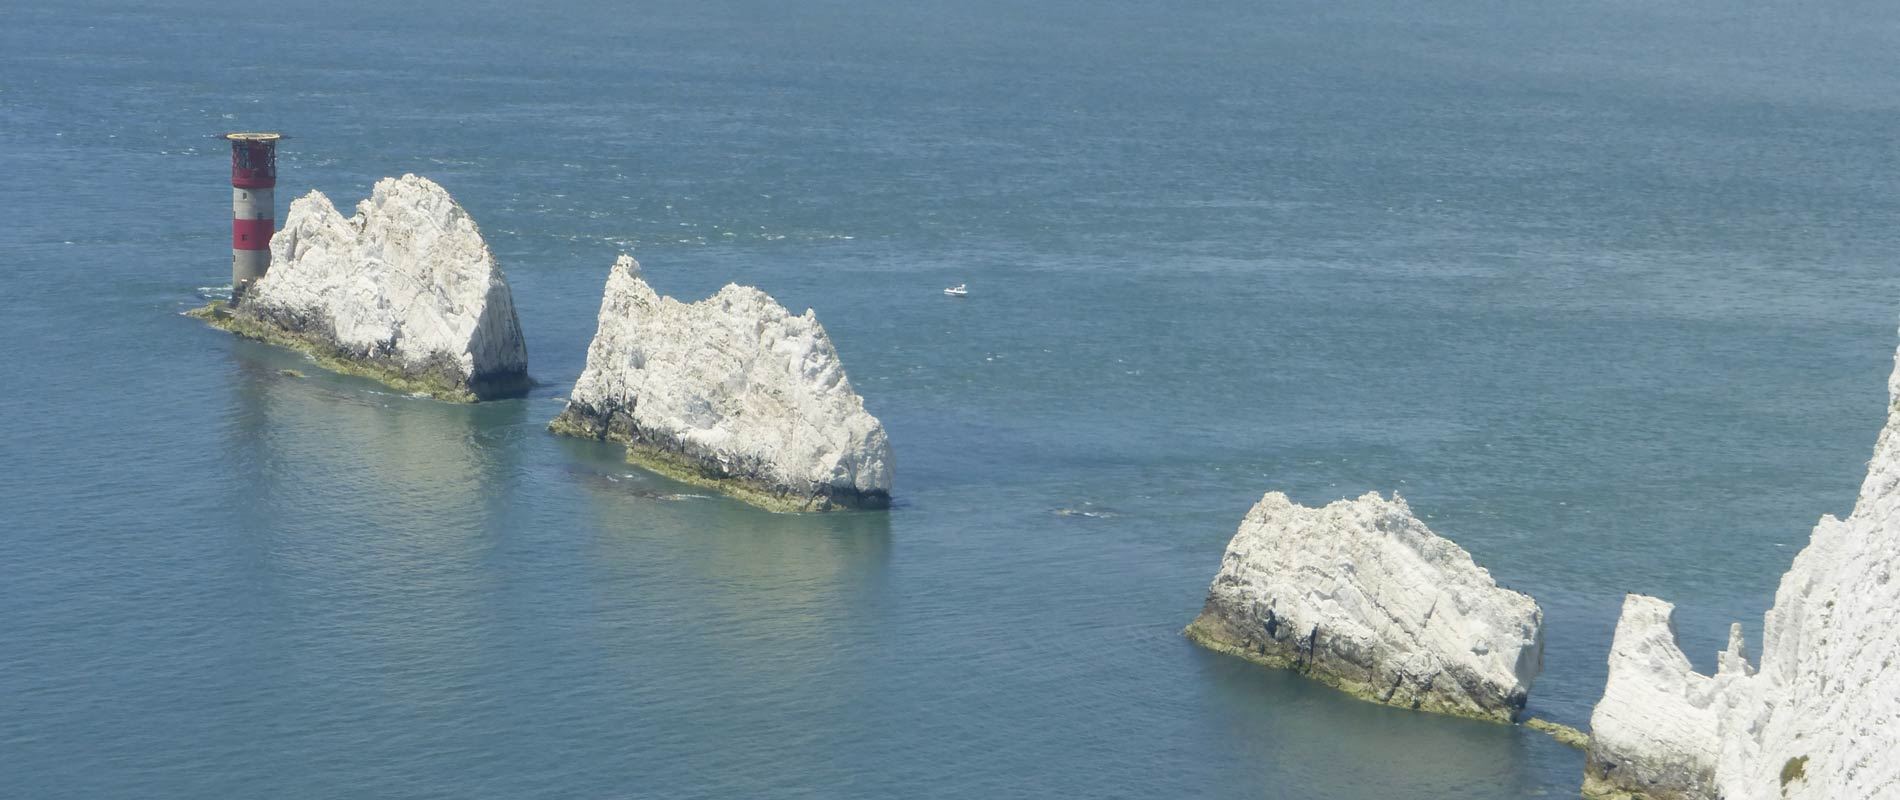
[0, 0, 1900, 800]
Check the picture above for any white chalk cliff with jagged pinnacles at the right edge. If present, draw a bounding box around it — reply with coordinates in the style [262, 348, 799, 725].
[1585, 326, 1900, 800]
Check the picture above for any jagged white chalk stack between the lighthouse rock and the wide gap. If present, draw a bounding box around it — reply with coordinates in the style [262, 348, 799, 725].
[549, 257, 891, 511]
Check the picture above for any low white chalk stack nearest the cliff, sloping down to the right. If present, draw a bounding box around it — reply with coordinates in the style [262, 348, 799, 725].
[1186, 492, 1543, 722]
